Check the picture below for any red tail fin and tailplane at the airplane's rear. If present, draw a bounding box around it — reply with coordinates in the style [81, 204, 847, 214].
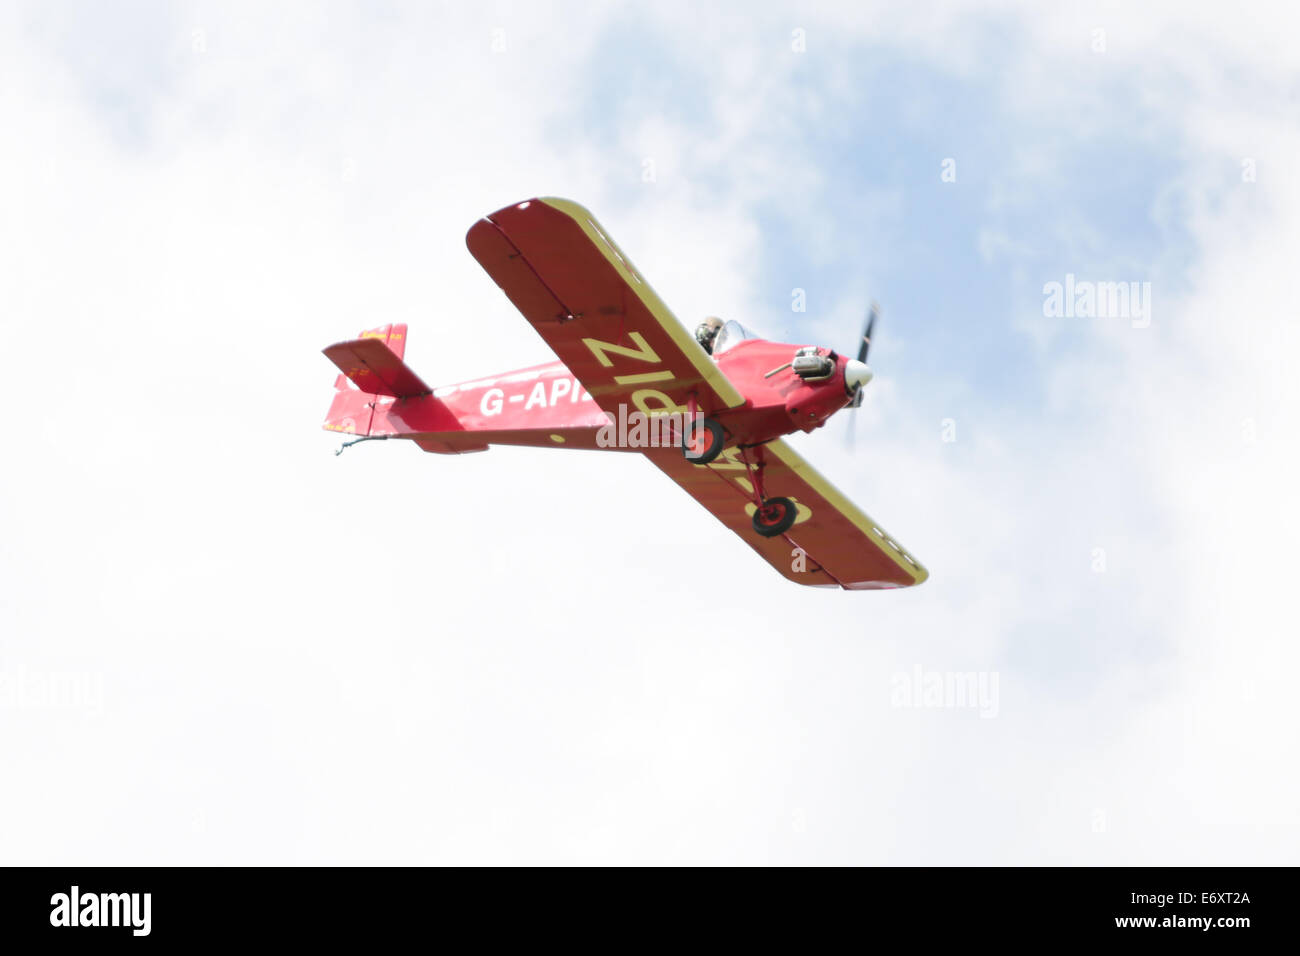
[324, 324, 432, 436]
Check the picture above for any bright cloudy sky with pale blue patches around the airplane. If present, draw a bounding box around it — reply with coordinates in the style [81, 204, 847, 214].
[0, 3, 1300, 865]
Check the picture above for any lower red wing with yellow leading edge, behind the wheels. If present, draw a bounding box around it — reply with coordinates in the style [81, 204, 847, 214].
[645, 438, 930, 591]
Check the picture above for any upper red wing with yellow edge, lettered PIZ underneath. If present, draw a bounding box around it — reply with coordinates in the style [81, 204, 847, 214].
[465, 199, 745, 415]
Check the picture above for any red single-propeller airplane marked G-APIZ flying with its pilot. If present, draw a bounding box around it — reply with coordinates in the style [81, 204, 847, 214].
[324, 199, 930, 591]
